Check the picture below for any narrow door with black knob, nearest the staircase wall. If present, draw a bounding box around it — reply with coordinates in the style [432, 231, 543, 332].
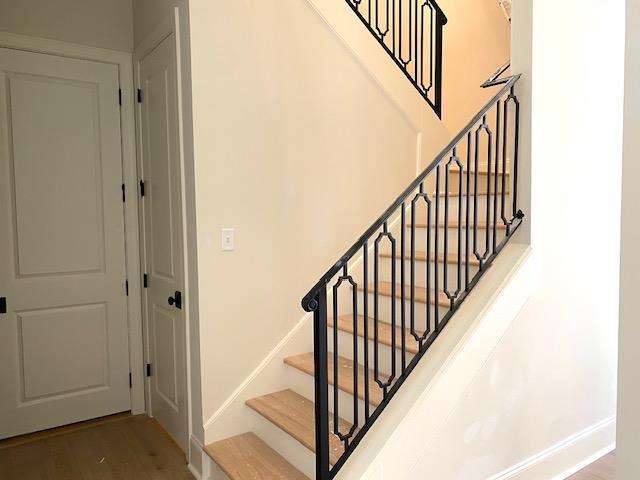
[138, 35, 188, 452]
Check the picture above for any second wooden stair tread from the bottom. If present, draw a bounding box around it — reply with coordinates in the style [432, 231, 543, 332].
[247, 390, 351, 465]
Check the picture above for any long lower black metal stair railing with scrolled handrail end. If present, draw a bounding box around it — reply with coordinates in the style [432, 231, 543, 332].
[302, 68, 524, 480]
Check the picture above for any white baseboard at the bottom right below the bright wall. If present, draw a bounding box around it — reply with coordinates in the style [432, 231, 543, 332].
[491, 416, 616, 480]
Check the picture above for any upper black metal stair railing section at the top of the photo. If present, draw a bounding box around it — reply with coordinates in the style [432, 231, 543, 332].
[346, 0, 447, 117]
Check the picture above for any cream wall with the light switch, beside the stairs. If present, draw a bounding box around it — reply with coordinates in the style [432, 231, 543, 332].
[190, 0, 446, 438]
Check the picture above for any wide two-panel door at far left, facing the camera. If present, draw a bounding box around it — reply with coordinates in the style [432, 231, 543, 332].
[0, 48, 130, 438]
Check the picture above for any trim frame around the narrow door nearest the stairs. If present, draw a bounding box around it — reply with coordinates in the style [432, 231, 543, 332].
[133, 6, 192, 454]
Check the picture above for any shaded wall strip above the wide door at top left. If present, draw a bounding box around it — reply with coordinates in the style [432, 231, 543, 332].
[0, 0, 133, 52]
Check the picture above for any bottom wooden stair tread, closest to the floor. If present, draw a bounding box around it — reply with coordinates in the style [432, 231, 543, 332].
[205, 432, 309, 480]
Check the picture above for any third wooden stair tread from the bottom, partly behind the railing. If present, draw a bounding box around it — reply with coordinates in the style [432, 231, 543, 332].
[284, 352, 387, 407]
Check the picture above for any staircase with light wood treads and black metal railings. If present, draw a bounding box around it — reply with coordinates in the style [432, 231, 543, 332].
[205, 0, 524, 480]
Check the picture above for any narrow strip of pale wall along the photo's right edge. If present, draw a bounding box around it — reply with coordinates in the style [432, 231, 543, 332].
[616, 0, 640, 479]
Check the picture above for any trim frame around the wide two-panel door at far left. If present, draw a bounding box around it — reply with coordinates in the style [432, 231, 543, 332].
[0, 32, 146, 415]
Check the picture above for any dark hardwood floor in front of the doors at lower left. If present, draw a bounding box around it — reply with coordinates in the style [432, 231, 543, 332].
[0, 415, 193, 480]
